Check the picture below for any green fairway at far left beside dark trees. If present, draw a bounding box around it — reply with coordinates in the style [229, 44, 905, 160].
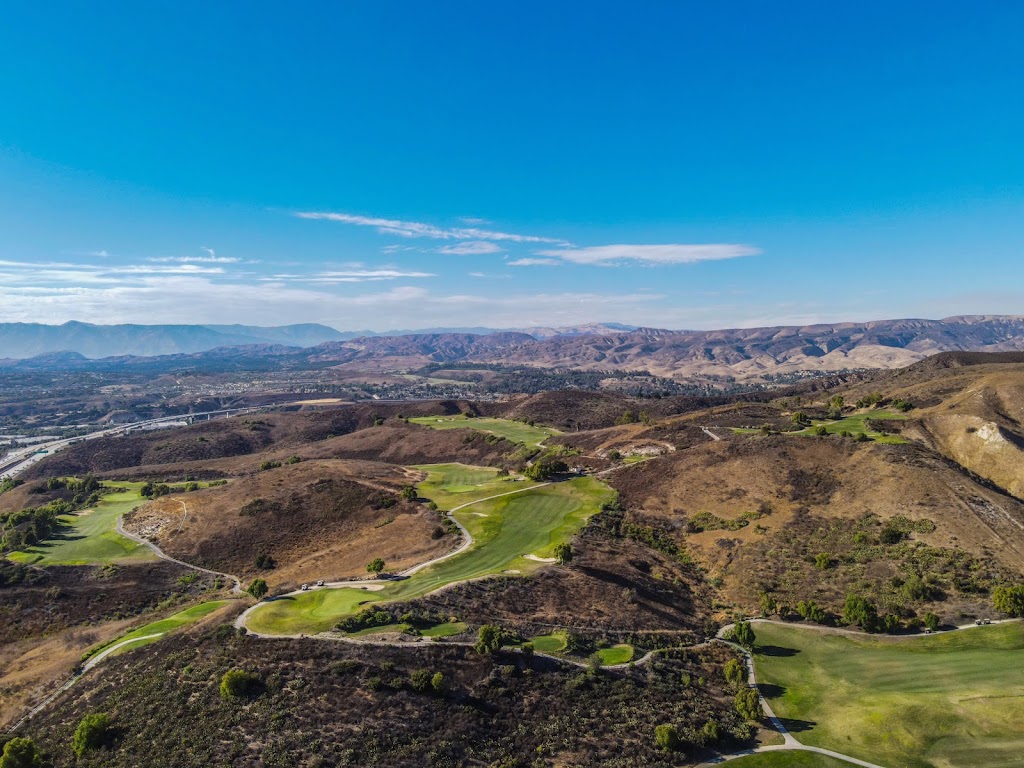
[9, 482, 156, 565]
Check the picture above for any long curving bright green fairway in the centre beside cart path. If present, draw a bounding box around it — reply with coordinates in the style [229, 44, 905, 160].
[248, 468, 613, 634]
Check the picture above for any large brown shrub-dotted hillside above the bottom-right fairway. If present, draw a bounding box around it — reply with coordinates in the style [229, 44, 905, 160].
[608, 436, 1024, 612]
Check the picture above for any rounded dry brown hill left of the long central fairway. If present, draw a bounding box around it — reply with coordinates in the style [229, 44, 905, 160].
[126, 461, 452, 587]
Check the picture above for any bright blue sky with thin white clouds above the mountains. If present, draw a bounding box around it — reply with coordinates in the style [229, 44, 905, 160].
[0, 2, 1024, 331]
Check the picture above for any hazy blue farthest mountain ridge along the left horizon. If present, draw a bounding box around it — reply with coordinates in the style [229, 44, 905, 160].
[0, 322, 633, 359]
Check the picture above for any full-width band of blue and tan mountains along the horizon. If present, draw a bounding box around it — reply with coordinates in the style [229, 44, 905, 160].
[0, 315, 1024, 380]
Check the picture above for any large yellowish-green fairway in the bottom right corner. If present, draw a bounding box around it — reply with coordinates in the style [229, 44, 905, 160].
[756, 623, 1024, 768]
